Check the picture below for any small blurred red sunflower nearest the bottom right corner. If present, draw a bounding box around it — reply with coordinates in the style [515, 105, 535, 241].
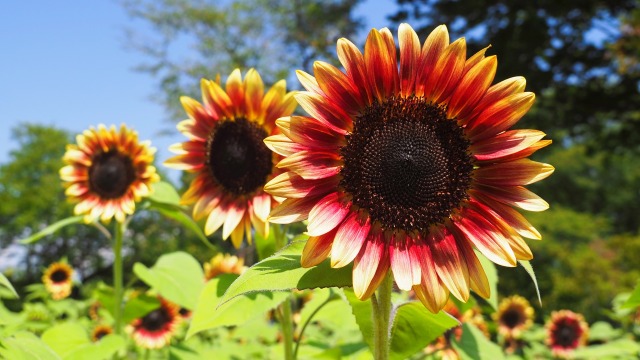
[546, 310, 589, 358]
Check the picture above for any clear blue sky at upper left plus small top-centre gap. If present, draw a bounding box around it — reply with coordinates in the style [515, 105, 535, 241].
[0, 0, 396, 175]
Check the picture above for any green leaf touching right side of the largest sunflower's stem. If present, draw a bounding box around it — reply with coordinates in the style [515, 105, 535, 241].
[389, 301, 460, 359]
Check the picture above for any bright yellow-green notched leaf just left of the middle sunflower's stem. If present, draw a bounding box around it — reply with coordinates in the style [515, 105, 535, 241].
[187, 274, 289, 338]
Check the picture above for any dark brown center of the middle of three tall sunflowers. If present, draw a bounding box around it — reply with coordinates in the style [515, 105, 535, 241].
[207, 118, 272, 195]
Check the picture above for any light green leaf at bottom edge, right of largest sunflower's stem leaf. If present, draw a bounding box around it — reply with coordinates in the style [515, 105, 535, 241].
[453, 323, 504, 360]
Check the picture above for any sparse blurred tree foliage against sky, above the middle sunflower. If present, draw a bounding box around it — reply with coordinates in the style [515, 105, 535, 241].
[123, 0, 361, 120]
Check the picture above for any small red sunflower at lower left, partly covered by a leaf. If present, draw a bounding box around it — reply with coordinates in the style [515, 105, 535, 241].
[127, 298, 181, 349]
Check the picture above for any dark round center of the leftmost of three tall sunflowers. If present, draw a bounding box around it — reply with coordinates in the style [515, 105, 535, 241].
[89, 150, 136, 199]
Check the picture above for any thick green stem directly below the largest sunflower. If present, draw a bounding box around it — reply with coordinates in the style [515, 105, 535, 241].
[371, 274, 393, 360]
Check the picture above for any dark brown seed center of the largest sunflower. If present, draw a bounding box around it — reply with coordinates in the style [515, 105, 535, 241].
[340, 96, 473, 232]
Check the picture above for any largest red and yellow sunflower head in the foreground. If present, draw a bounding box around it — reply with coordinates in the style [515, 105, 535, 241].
[265, 24, 553, 312]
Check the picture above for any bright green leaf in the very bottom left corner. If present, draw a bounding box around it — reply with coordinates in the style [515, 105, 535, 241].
[0, 331, 62, 360]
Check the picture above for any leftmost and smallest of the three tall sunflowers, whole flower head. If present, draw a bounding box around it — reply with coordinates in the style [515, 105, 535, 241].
[60, 124, 160, 222]
